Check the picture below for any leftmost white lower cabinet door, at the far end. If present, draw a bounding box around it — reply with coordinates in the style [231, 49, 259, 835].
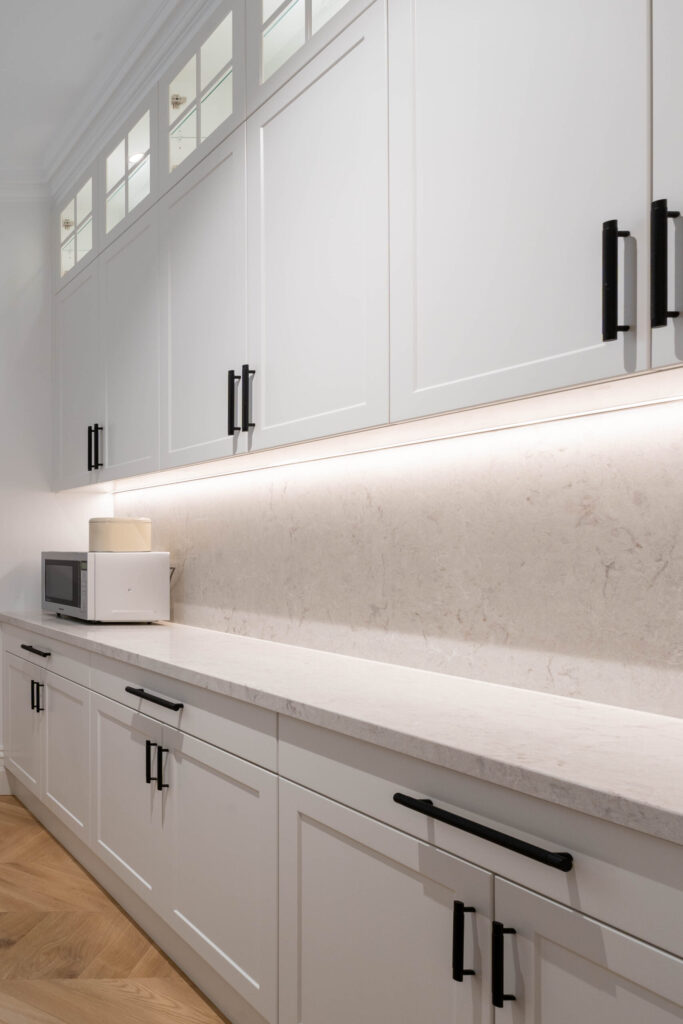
[4, 654, 45, 797]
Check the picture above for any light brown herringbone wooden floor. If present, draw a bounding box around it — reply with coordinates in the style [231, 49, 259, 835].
[0, 797, 231, 1024]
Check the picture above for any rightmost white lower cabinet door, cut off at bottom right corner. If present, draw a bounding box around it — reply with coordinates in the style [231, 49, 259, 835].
[494, 879, 683, 1024]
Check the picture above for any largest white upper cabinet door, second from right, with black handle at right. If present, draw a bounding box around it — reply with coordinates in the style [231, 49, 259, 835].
[389, 0, 651, 420]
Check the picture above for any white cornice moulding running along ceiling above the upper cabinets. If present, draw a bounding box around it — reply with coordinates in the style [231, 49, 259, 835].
[44, 0, 220, 198]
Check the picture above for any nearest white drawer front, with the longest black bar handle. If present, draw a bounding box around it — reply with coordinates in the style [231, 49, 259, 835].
[279, 717, 683, 956]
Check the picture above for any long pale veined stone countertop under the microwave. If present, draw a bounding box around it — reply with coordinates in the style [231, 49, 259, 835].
[0, 612, 683, 845]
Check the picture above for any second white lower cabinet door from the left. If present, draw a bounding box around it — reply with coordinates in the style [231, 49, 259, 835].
[41, 672, 90, 843]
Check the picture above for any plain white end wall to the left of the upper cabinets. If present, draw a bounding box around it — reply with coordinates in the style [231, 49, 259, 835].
[0, 192, 111, 784]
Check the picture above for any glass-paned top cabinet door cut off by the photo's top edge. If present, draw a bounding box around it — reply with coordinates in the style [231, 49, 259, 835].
[247, 0, 373, 114]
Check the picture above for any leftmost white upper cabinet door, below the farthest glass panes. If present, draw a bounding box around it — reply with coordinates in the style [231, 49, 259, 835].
[54, 261, 104, 487]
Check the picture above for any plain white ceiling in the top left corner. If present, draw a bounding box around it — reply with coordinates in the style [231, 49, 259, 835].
[0, 0, 179, 182]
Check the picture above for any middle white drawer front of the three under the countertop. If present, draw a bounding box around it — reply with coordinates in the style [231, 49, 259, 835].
[91, 654, 278, 770]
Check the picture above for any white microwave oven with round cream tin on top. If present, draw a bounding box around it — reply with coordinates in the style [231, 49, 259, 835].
[42, 551, 171, 623]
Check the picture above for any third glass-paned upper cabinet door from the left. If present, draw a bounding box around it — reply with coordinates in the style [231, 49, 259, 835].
[167, 8, 239, 173]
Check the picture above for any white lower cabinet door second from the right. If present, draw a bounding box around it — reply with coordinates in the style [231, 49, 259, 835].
[280, 780, 493, 1024]
